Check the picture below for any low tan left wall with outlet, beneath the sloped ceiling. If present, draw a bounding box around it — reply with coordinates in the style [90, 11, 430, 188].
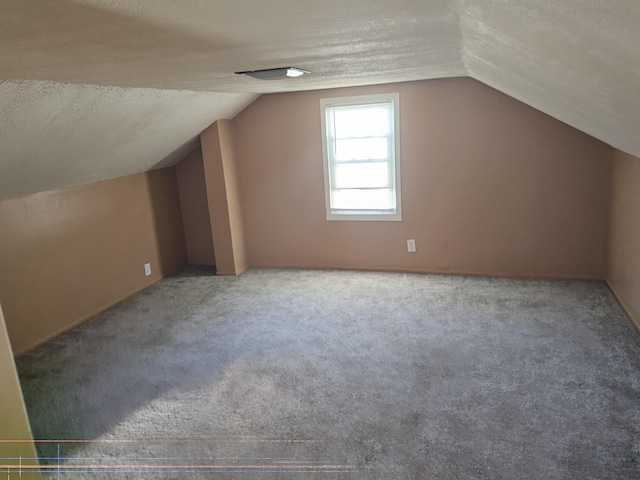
[0, 167, 186, 353]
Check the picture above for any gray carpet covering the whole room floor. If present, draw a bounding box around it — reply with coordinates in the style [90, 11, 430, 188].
[17, 269, 640, 480]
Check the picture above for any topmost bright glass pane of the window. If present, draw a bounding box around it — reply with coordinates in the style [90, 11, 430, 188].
[334, 104, 391, 138]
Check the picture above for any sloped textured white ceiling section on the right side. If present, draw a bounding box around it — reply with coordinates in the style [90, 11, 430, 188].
[460, 0, 640, 166]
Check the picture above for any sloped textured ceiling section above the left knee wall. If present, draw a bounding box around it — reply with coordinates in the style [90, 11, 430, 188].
[0, 81, 254, 198]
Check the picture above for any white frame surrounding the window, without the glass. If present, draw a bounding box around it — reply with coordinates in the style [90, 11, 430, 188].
[320, 92, 402, 221]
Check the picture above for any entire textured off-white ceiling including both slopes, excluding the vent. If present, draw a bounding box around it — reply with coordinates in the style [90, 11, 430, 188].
[0, 0, 640, 198]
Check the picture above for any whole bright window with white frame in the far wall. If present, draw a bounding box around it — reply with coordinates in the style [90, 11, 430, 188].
[320, 93, 402, 221]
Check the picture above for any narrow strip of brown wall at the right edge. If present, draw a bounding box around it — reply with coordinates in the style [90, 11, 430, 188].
[607, 151, 640, 329]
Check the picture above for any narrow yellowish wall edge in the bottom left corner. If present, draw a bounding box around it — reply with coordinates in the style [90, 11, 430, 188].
[0, 306, 41, 479]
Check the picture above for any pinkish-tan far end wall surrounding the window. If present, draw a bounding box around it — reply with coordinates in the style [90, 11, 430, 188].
[234, 78, 611, 278]
